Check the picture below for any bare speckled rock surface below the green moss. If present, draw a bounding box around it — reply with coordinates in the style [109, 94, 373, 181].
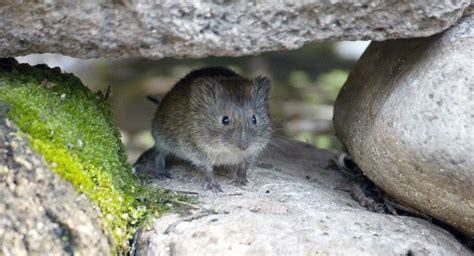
[0, 113, 111, 255]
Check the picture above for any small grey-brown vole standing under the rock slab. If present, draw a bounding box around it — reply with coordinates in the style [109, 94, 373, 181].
[152, 67, 272, 192]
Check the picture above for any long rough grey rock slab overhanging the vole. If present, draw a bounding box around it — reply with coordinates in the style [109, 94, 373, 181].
[0, 0, 471, 58]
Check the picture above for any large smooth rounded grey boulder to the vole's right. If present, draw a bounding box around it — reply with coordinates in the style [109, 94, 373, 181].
[334, 15, 474, 236]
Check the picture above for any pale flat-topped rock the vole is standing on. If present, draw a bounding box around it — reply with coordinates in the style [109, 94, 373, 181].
[137, 141, 470, 255]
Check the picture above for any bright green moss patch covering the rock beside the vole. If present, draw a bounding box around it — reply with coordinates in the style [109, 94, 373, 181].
[0, 59, 183, 253]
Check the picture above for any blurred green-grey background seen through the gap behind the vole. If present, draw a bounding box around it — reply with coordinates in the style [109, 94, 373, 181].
[17, 41, 369, 163]
